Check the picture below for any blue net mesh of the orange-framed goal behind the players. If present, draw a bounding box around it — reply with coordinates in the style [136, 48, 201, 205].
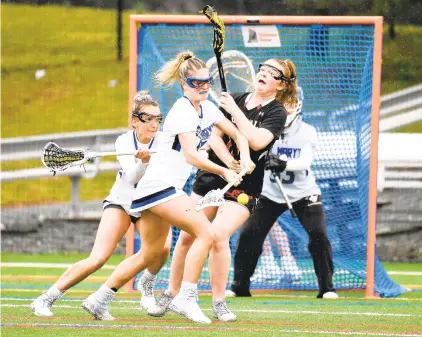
[135, 24, 405, 297]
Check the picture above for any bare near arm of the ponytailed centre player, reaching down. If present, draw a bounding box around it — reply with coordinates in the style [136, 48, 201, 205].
[178, 132, 237, 181]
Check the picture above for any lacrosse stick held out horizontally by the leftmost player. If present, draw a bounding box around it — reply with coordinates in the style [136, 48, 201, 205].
[41, 142, 155, 174]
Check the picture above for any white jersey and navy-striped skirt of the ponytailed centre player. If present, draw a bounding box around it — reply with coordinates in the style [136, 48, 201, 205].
[131, 97, 224, 216]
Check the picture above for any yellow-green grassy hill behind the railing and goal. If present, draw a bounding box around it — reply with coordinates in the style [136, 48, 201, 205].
[1, 4, 422, 205]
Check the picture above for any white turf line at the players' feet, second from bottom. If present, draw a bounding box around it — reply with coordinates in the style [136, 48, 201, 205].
[0, 301, 422, 317]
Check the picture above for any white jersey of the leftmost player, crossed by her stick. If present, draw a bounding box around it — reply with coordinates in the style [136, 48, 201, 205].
[103, 130, 159, 211]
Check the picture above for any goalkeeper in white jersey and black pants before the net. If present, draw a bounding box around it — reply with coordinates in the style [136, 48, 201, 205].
[231, 90, 338, 298]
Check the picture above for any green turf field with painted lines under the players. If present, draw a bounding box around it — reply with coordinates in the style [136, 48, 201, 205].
[1, 254, 422, 337]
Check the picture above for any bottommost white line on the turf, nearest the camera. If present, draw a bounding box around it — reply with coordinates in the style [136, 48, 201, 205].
[3, 323, 422, 337]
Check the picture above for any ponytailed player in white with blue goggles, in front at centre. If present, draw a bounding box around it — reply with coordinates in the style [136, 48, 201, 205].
[82, 52, 255, 324]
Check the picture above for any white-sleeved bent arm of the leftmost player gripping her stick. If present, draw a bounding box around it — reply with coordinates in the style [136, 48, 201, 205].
[115, 137, 149, 185]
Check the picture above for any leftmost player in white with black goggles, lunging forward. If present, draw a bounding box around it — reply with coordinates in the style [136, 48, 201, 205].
[31, 91, 171, 319]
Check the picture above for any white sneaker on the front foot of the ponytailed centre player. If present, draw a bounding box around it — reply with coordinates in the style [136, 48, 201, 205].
[169, 288, 211, 324]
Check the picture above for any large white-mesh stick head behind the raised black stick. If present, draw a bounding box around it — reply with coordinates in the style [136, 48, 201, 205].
[206, 50, 255, 104]
